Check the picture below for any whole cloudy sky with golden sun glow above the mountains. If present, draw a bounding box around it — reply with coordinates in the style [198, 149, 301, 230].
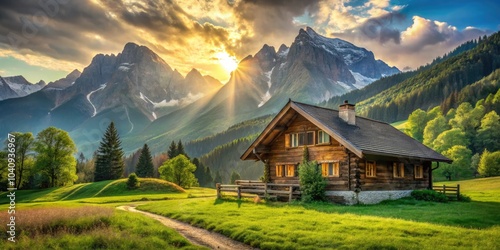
[0, 0, 500, 83]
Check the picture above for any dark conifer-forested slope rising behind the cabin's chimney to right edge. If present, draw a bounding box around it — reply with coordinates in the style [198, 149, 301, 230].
[324, 33, 500, 122]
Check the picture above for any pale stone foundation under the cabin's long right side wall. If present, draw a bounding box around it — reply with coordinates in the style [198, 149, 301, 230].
[326, 190, 413, 205]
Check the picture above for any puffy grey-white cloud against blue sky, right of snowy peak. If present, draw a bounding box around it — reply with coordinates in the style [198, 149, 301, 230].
[331, 14, 491, 69]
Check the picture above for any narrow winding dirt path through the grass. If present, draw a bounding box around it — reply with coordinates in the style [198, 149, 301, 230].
[117, 206, 254, 250]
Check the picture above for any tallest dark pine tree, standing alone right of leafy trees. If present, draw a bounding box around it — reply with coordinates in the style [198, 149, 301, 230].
[94, 122, 125, 181]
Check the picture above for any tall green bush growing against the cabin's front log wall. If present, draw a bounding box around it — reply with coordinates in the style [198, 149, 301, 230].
[299, 162, 326, 202]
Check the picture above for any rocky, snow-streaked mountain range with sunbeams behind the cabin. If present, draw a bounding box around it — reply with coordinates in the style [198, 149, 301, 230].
[0, 28, 400, 156]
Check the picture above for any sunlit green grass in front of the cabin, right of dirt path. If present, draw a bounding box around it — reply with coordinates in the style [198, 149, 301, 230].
[139, 177, 500, 249]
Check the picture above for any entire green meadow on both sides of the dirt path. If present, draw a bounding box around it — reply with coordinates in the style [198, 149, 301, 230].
[0, 177, 500, 249]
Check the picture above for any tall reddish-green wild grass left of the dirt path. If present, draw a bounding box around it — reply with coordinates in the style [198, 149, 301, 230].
[0, 206, 205, 249]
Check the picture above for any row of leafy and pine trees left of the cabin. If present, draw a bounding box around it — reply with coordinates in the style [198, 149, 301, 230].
[0, 122, 235, 189]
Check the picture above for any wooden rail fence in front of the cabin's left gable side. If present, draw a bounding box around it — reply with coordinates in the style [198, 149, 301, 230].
[215, 180, 301, 201]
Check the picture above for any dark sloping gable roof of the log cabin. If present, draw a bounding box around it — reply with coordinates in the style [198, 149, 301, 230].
[241, 101, 452, 162]
